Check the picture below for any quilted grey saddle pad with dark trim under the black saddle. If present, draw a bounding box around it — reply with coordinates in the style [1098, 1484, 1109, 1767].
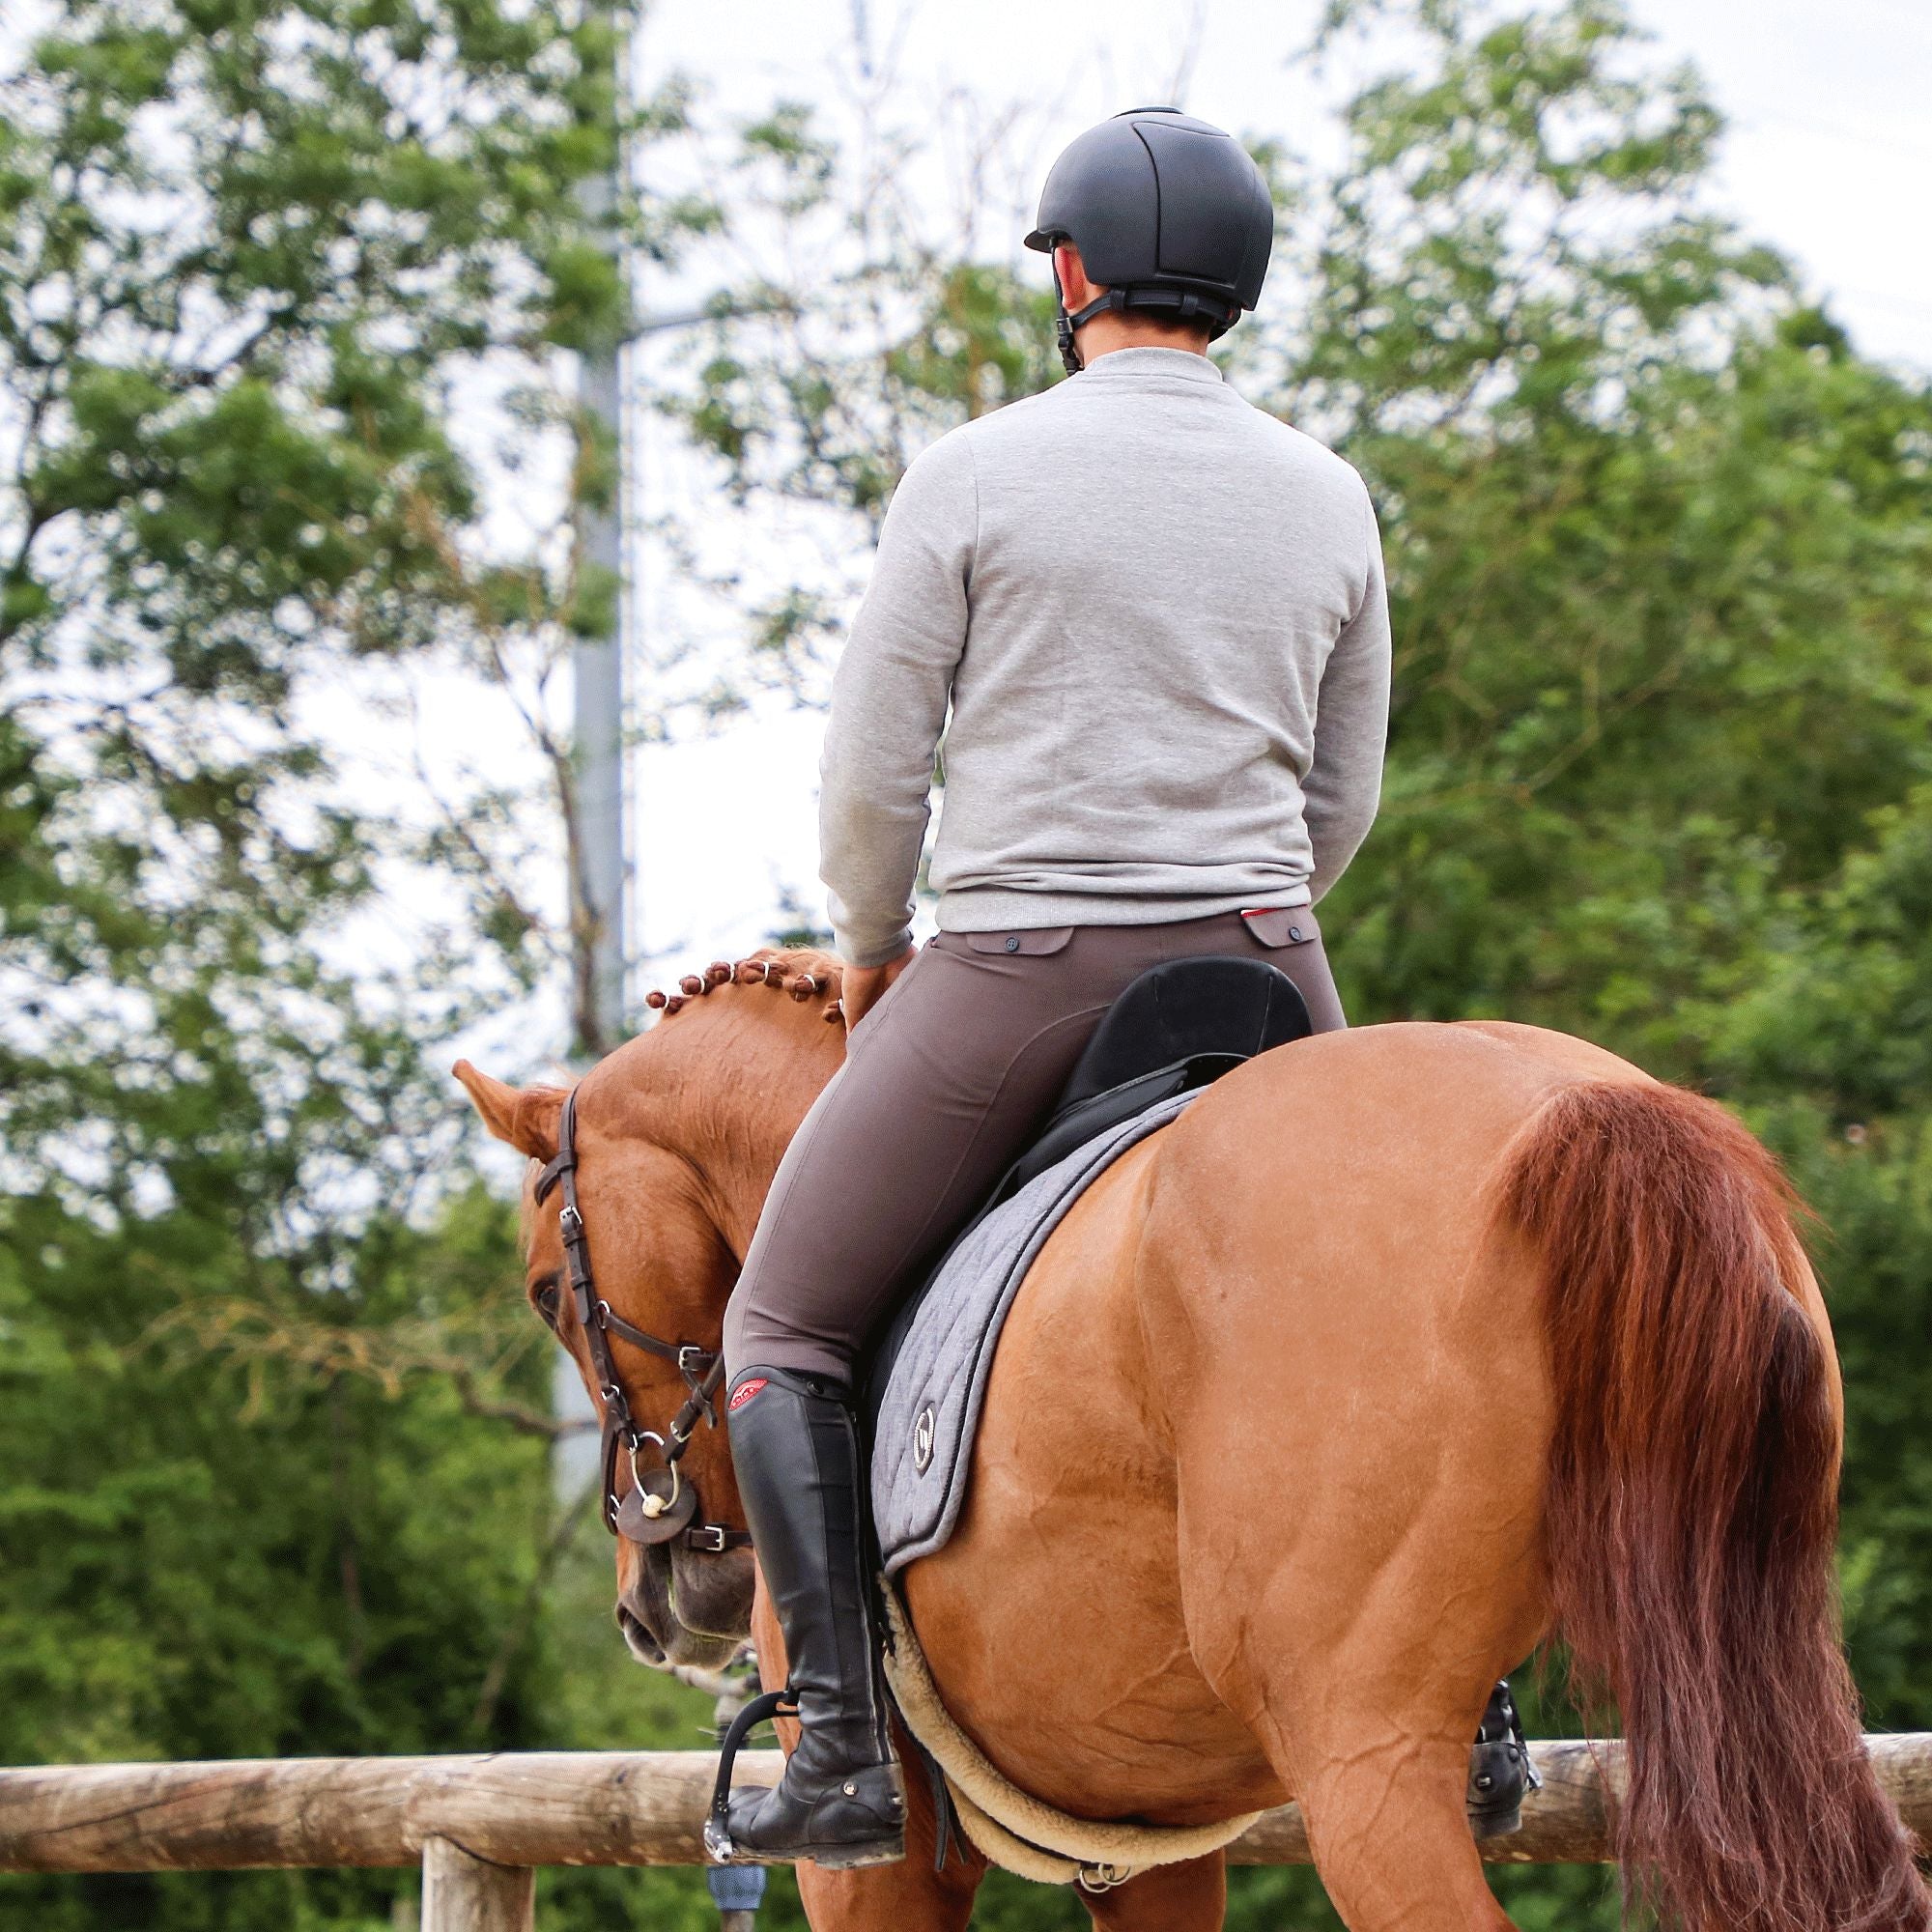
[871, 1088, 1204, 1577]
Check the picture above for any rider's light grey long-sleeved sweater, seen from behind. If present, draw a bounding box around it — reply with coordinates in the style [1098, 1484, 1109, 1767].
[819, 350, 1389, 966]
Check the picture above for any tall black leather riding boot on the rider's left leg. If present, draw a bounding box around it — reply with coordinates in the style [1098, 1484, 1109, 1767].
[719, 1368, 906, 1868]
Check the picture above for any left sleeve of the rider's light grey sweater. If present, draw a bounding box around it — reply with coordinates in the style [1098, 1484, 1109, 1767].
[819, 431, 980, 966]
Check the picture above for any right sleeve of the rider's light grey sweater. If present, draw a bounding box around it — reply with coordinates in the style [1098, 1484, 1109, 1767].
[1302, 491, 1389, 900]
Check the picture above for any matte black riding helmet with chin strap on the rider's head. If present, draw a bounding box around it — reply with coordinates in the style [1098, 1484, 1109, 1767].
[1026, 108, 1275, 375]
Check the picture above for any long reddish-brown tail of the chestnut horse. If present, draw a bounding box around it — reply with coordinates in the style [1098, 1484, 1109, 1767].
[1501, 1082, 1928, 1932]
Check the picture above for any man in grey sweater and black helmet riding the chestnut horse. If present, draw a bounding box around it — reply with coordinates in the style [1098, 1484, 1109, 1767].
[724, 108, 1389, 1866]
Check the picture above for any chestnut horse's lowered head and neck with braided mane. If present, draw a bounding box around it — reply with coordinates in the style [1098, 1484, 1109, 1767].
[456, 954, 842, 1665]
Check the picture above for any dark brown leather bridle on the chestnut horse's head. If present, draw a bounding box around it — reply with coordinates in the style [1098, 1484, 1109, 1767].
[537, 1092, 752, 1555]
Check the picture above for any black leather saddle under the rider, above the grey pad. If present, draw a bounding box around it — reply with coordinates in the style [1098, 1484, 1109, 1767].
[866, 956, 1314, 1418]
